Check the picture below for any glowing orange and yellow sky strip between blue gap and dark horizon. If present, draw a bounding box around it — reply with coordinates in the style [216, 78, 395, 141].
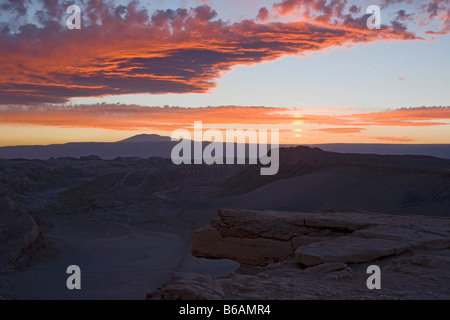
[0, 105, 450, 146]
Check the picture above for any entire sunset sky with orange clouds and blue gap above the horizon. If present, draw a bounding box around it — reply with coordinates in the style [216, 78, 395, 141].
[0, 0, 450, 146]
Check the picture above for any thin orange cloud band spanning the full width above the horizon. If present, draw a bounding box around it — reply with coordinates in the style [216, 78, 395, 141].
[0, 104, 450, 133]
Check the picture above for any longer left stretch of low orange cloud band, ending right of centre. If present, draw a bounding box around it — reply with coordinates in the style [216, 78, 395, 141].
[0, 105, 293, 131]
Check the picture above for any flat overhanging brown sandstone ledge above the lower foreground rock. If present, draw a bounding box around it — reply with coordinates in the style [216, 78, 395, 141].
[192, 210, 450, 266]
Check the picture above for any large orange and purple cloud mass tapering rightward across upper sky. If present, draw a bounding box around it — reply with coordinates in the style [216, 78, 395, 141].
[0, 0, 432, 105]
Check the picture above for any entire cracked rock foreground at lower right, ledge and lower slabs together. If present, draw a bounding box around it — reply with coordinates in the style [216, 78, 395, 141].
[147, 210, 450, 300]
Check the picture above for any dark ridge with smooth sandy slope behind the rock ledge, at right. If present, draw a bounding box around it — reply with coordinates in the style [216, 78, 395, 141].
[219, 147, 450, 216]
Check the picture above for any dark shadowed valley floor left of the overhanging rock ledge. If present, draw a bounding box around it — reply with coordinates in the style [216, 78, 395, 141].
[0, 156, 243, 299]
